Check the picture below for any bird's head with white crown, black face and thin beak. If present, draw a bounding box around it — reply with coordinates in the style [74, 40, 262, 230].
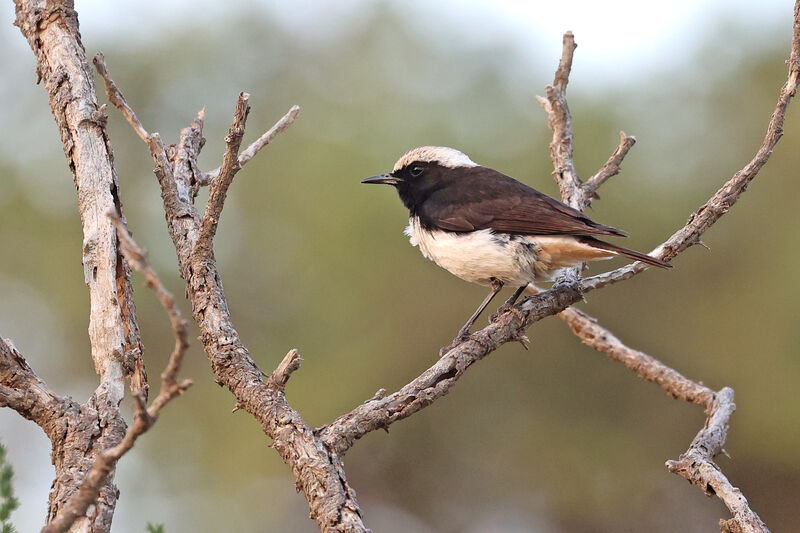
[361, 146, 478, 212]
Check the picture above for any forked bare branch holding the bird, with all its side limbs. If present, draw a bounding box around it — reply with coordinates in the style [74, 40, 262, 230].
[86, 1, 800, 531]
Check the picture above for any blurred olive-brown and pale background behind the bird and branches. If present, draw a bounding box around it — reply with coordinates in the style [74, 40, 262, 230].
[0, 0, 800, 533]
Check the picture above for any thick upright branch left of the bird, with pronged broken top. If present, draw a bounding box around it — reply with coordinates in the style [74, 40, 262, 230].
[93, 57, 368, 532]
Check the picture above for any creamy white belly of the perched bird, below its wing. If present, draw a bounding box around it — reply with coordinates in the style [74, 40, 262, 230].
[405, 218, 613, 286]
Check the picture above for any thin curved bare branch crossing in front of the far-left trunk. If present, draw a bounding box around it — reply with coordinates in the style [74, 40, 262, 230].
[42, 217, 192, 533]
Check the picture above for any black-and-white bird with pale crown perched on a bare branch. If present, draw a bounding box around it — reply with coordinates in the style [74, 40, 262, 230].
[361, 146, 672, 339]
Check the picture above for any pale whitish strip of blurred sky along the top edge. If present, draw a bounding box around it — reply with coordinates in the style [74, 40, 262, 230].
[0, 0, 792, 81]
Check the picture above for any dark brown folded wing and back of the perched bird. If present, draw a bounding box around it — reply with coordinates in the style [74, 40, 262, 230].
[417, 167, 625, 236]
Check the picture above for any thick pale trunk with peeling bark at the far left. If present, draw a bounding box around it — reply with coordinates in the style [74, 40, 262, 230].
[15, 0, 147, 532]
